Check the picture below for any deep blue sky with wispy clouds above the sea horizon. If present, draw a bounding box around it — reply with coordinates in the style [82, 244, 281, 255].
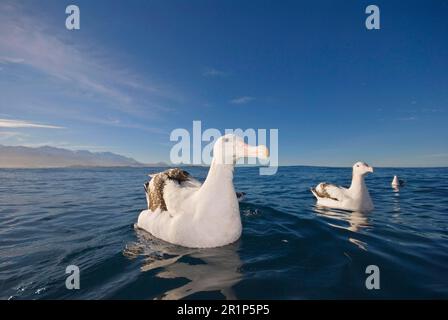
[0, 0, 448, 166]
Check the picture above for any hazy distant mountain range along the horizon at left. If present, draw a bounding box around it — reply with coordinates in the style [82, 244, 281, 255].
[0, 145, 167, 168]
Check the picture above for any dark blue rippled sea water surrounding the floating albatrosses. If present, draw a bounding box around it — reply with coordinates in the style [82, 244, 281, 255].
[0, 167, 448, 299]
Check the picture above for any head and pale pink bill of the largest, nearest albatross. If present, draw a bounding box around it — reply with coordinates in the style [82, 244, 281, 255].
[213, 134, 269, 164]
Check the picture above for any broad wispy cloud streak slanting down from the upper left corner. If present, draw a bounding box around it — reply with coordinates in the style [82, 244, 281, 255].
[0, 1, 179, 118]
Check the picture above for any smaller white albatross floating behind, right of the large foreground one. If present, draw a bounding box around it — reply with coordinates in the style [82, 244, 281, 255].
[311, 162, 373, 212]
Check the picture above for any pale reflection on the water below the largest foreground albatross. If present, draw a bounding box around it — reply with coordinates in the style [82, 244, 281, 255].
[123, 229, 242, 300]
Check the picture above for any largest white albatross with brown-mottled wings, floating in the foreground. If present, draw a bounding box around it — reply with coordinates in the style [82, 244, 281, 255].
[137, 134, 269, 248]
